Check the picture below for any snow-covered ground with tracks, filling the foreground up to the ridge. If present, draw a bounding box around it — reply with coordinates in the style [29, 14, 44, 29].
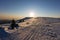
[0, 17, 60, 40]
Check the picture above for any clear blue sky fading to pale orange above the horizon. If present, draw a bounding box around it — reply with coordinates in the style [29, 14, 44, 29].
[0, 0, 60, 18]
